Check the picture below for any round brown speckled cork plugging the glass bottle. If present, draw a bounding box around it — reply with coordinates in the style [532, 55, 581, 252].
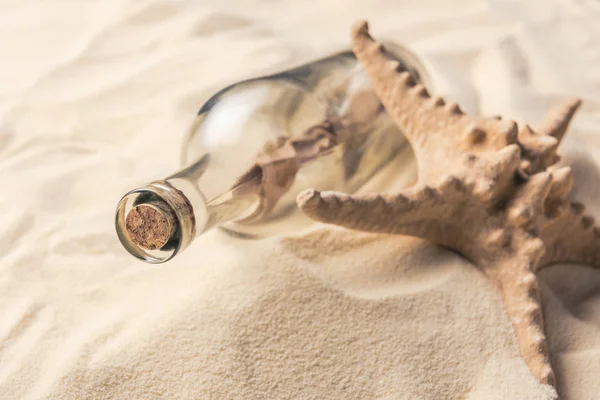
[125, 204, 174, 250]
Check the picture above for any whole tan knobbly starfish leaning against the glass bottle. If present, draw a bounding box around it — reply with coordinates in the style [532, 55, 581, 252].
[297, 21, 600, 387]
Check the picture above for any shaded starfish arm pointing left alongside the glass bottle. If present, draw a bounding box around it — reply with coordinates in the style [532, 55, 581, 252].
[297, 181, 461, 243]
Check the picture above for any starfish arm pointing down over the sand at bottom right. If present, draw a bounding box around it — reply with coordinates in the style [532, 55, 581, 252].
[490, 256, 555, 386]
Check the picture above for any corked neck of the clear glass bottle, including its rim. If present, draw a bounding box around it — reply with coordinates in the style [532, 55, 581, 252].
[115, 160, 259, 264]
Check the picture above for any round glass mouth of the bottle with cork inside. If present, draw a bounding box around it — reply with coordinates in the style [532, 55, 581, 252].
[115, 181, 195, 264]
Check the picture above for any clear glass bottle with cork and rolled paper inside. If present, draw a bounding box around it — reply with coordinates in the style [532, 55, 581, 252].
[116, 42, 431, 263]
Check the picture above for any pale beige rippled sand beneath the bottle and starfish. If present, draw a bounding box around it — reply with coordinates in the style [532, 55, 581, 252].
[0, 0, 600, 400]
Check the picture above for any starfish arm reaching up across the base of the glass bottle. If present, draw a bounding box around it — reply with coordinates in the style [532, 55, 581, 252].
[352, 21, 518, 184]
